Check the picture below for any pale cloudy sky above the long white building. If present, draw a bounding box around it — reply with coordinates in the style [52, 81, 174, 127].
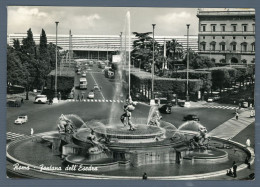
[7, 6, 198, 36]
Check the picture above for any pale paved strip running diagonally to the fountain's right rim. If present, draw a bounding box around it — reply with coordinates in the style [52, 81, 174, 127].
[208, 110, 255, 140]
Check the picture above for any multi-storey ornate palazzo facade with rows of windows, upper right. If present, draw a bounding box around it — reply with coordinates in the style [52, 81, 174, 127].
[197, 8, 255, 64]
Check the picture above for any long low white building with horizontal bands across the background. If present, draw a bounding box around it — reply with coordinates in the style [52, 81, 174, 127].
[7, 33, 198, 58]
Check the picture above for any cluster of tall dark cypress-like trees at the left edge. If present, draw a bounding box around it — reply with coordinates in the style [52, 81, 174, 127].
[7, 29, 61, 99]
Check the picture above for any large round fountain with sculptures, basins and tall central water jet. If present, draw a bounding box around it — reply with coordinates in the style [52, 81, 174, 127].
[7, 12, 252, 179]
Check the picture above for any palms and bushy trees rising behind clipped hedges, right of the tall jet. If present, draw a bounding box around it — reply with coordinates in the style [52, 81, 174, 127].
[131, 32, 215, 73]
